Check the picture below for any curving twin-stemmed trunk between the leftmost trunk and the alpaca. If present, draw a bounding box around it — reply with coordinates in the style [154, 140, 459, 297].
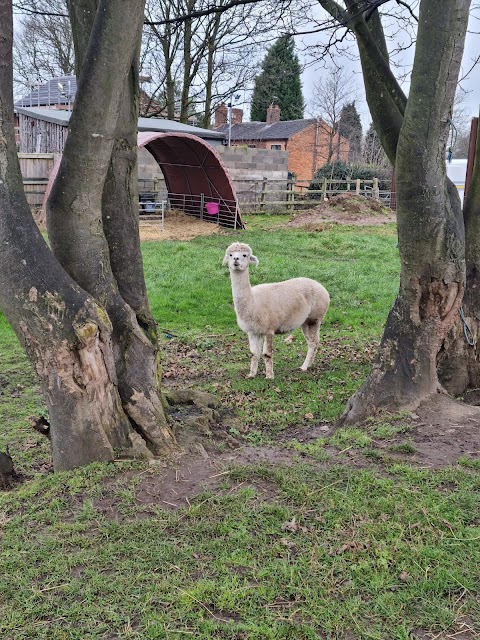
[47, 0, 174, 454]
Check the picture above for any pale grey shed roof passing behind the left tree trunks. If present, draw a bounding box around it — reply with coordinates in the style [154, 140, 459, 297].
[15, 107, 225, 140]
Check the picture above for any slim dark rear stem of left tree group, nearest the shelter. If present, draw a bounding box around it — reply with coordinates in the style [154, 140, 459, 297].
[102, 57, 173, 453]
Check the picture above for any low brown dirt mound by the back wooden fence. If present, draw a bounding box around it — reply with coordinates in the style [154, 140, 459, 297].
[285, 193, 396, 231]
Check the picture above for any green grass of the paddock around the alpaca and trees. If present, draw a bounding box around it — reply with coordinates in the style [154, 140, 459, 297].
[0, 216, 480, 640]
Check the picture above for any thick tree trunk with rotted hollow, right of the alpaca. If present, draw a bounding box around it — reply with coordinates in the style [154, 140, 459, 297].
[343, 0, 470, 422]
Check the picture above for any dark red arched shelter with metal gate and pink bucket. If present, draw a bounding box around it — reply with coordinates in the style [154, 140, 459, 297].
[138, 131, 243, 228]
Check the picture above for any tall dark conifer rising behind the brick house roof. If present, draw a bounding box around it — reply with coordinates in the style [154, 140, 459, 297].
[250, 36, 304, 122]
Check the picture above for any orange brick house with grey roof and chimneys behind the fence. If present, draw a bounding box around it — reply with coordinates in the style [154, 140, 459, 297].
[215, 105, 349, 180]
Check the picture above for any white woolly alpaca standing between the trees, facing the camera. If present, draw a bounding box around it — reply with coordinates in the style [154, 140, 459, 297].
[223, 242, 330, 378]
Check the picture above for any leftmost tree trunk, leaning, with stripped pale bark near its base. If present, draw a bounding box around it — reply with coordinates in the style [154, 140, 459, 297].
[0, 1, 136, 470]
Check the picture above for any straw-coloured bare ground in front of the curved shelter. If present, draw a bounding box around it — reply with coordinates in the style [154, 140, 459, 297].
[140, 211, 223, 242]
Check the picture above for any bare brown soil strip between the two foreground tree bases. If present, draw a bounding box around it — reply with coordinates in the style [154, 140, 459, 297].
[127, 389, 480, 520]
